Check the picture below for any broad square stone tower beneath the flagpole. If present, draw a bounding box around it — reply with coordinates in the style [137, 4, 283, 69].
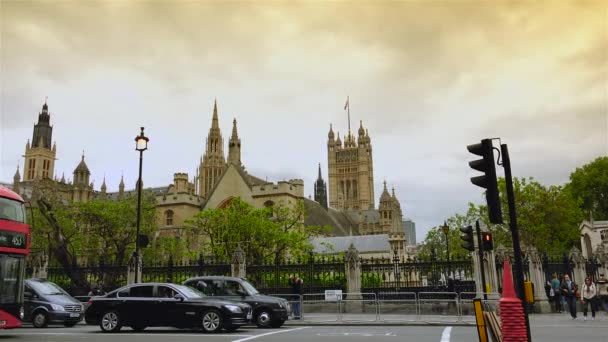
[327, 122, 374, 210]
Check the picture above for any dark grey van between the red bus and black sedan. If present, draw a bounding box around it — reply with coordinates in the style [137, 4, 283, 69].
[23, 278, 84, 328]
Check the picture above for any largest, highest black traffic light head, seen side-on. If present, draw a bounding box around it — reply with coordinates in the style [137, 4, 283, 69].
[467, 139, 503, 223]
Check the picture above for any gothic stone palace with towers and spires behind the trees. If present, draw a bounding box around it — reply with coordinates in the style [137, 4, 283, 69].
[5, 102, 414, 255]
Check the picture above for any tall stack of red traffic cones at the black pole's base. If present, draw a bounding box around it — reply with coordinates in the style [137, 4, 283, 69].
[499, 258, 528, 342]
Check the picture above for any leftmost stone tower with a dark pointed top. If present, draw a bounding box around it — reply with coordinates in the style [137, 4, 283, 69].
[23, 102, 57, 181]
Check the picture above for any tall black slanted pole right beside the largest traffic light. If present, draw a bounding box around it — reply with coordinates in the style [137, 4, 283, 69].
[500, 144, 532, 341]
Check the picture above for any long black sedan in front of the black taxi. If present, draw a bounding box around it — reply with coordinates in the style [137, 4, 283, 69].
[85, 283, 251, 332]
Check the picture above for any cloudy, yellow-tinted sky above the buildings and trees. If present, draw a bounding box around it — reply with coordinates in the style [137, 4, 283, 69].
[0, 0, 608, 241]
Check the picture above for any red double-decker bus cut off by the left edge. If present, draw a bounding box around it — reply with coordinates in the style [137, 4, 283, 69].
[0, 185, 30, 329]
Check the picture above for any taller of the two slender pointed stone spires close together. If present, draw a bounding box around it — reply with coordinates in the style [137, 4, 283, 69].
[198, 100, 226, 197]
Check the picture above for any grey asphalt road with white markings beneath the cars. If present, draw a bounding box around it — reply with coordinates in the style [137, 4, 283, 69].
[0, 314, 608, 342]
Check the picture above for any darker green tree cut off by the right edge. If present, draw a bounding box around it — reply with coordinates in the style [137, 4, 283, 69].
[566, 157, 608, 220]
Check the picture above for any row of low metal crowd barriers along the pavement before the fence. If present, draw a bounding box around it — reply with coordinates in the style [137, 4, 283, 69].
[272, 292, 490, 324]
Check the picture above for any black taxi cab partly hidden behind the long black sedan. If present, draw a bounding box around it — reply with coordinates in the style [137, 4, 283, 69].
[183, 276, 291, 328]
